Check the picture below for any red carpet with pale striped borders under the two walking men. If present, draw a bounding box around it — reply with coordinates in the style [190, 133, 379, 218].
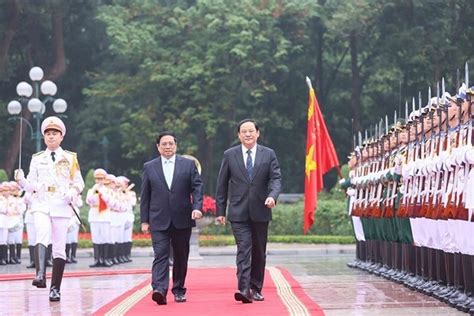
[94, 267, 324, 316]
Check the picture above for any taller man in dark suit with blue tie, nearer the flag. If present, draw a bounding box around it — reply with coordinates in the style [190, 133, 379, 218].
[216, 119, 281, 303]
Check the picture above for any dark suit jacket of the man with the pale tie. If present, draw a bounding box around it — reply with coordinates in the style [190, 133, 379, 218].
[140, 155, 203, 231]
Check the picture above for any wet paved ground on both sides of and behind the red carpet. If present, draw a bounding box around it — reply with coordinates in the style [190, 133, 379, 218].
[0, 244, 462, 316]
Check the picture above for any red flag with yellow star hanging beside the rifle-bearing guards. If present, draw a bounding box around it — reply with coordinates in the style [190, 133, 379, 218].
[303, 82, 339, 234]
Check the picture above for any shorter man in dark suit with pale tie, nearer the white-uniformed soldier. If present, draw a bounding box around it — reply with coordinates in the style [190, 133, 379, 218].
[140, 132, 203, 305]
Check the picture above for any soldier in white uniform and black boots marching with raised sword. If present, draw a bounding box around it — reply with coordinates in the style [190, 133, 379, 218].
[15, 116, 84, 302]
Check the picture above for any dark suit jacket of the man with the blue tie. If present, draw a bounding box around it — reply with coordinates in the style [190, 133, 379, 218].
[216, 144, 281, 222]
